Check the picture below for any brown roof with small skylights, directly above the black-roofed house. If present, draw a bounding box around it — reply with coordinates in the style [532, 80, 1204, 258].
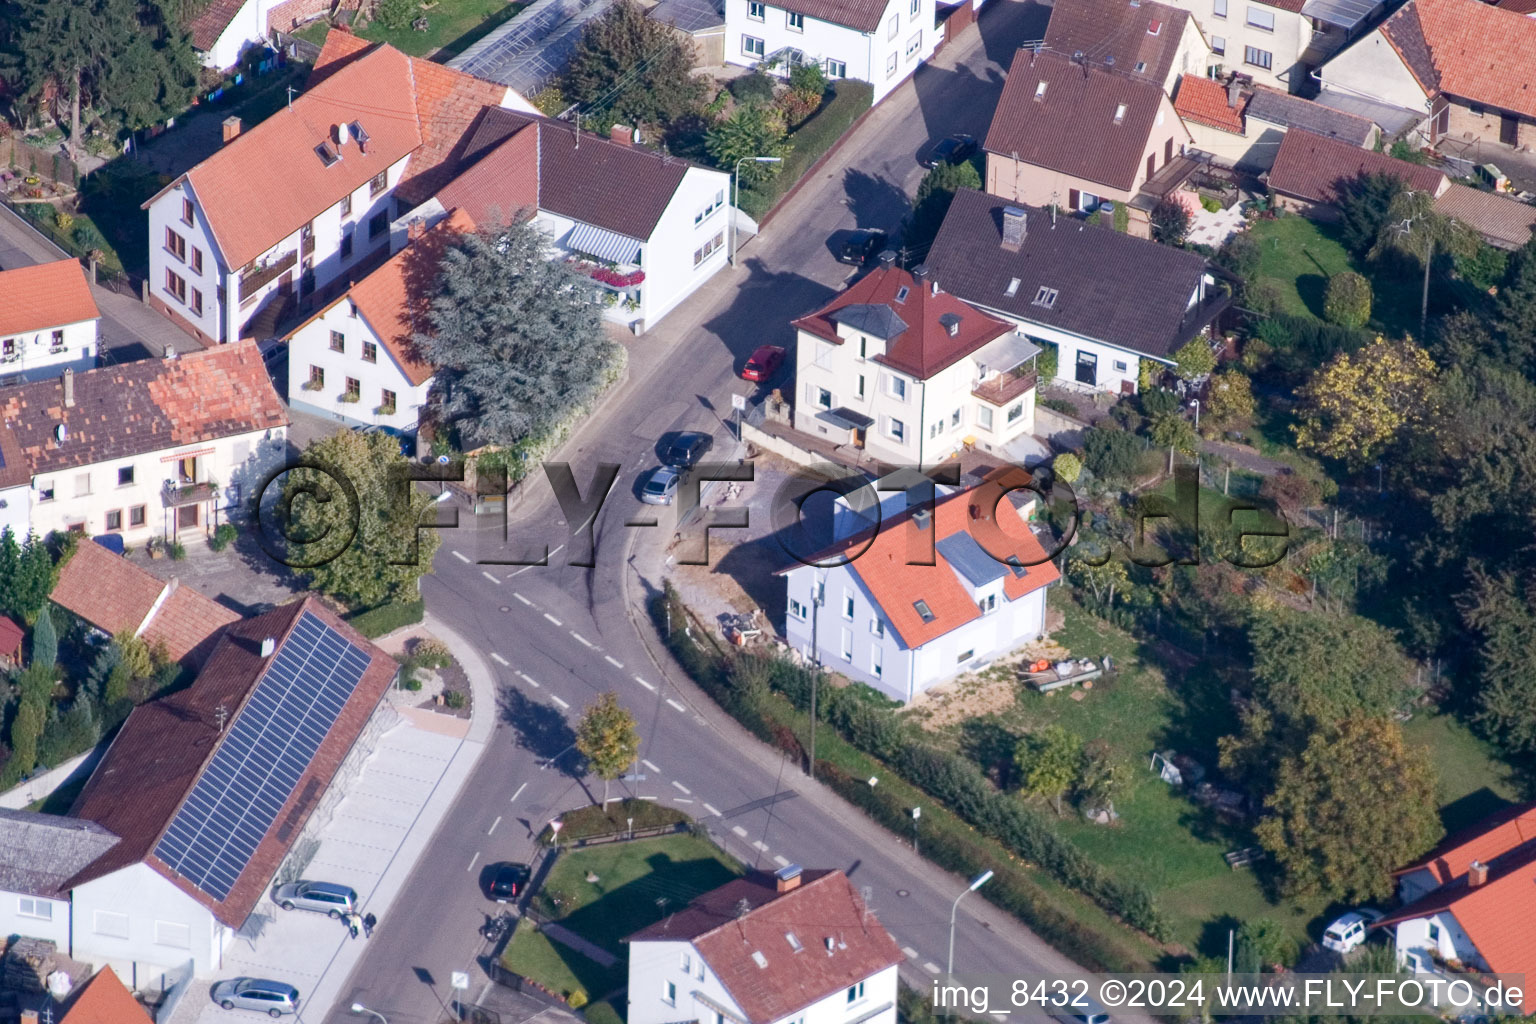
[986, 49, 1163, 189]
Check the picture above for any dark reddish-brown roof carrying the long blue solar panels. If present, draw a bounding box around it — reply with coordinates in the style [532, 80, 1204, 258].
[68, 597, 398, 927]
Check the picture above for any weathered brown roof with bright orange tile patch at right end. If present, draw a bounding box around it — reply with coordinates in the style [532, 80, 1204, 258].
[0, 341, 287, 476]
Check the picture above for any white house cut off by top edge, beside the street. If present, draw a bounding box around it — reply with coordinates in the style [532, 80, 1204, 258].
[725, 0, 943, 103]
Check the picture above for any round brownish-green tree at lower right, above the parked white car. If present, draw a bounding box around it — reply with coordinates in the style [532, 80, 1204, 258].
[1253, 717, 1444, 900]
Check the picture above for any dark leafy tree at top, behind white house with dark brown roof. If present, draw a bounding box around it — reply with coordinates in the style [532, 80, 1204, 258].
[561, 0, 703, 124]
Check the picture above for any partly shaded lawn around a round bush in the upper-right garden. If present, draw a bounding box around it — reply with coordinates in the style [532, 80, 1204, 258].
[1249, 215, 1421, 336]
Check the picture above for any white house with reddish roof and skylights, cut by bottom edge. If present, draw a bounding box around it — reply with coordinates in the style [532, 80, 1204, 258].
[625, 864, 903, 1024]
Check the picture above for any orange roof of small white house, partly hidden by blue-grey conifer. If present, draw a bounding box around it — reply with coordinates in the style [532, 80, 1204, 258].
[289, 210, 475, 384]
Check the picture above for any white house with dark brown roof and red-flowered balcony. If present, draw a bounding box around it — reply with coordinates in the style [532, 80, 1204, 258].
[421, 111, 733, 333]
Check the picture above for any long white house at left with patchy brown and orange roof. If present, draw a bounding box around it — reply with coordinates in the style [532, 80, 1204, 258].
[0, 342, 287, 545]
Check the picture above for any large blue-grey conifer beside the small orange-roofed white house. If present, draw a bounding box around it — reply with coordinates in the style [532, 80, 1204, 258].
[416, 224, 622, 445]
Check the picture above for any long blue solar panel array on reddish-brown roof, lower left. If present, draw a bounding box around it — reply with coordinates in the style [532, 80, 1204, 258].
[155, 611, 369, 900]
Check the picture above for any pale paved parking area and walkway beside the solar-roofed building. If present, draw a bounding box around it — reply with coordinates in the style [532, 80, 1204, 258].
[167, 614, 496, 1024]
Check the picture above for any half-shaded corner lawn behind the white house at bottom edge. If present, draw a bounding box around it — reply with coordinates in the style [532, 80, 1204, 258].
[519, 834, 743, 951]
